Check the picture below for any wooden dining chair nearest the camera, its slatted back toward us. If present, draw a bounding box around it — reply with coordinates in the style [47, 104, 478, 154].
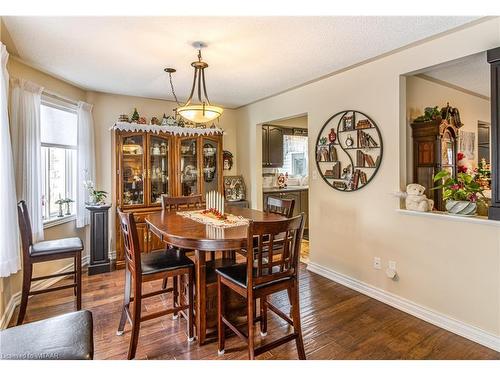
[216, 213, 306, 359]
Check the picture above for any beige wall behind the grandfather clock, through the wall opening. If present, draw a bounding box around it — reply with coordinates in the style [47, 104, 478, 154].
[406, 75, 491, 182]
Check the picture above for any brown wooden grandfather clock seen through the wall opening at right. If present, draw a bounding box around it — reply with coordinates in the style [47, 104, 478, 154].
[410, 119, 458, 211]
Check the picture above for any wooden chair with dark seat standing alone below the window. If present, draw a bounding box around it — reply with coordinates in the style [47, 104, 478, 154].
[16, 201, 83, 325]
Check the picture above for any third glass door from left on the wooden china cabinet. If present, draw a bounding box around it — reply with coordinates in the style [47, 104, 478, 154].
[180, 138, 200, 195]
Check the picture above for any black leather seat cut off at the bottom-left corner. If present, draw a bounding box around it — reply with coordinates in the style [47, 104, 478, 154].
[0, 310, 94, 359]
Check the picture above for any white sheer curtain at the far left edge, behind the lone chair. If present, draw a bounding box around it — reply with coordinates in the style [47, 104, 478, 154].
[0, 43, 21, 277]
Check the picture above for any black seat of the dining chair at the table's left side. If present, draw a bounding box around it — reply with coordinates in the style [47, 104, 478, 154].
[141, 249, 194, 275]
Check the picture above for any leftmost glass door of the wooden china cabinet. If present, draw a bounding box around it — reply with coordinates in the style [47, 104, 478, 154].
[121, 135, 145, 205]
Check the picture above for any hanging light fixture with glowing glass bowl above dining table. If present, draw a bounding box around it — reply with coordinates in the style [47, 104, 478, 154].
[164, 42, 224, 124]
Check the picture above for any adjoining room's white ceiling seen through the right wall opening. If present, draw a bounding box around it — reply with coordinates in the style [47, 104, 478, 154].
[423, 52, 490, 97]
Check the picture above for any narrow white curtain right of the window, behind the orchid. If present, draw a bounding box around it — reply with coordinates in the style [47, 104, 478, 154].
[76, 102, 95, 228]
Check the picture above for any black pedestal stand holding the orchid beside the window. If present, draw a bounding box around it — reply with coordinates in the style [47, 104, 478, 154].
[87, 205, 111, 275]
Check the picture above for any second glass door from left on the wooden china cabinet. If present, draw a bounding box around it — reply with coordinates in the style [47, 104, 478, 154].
[149, 136, 170, 204]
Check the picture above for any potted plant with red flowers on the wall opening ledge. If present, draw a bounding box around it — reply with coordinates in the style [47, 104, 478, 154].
[432, 169, 484, 216]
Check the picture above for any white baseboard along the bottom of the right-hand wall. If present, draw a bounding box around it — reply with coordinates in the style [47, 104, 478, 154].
[307, 262, 500, 352]
